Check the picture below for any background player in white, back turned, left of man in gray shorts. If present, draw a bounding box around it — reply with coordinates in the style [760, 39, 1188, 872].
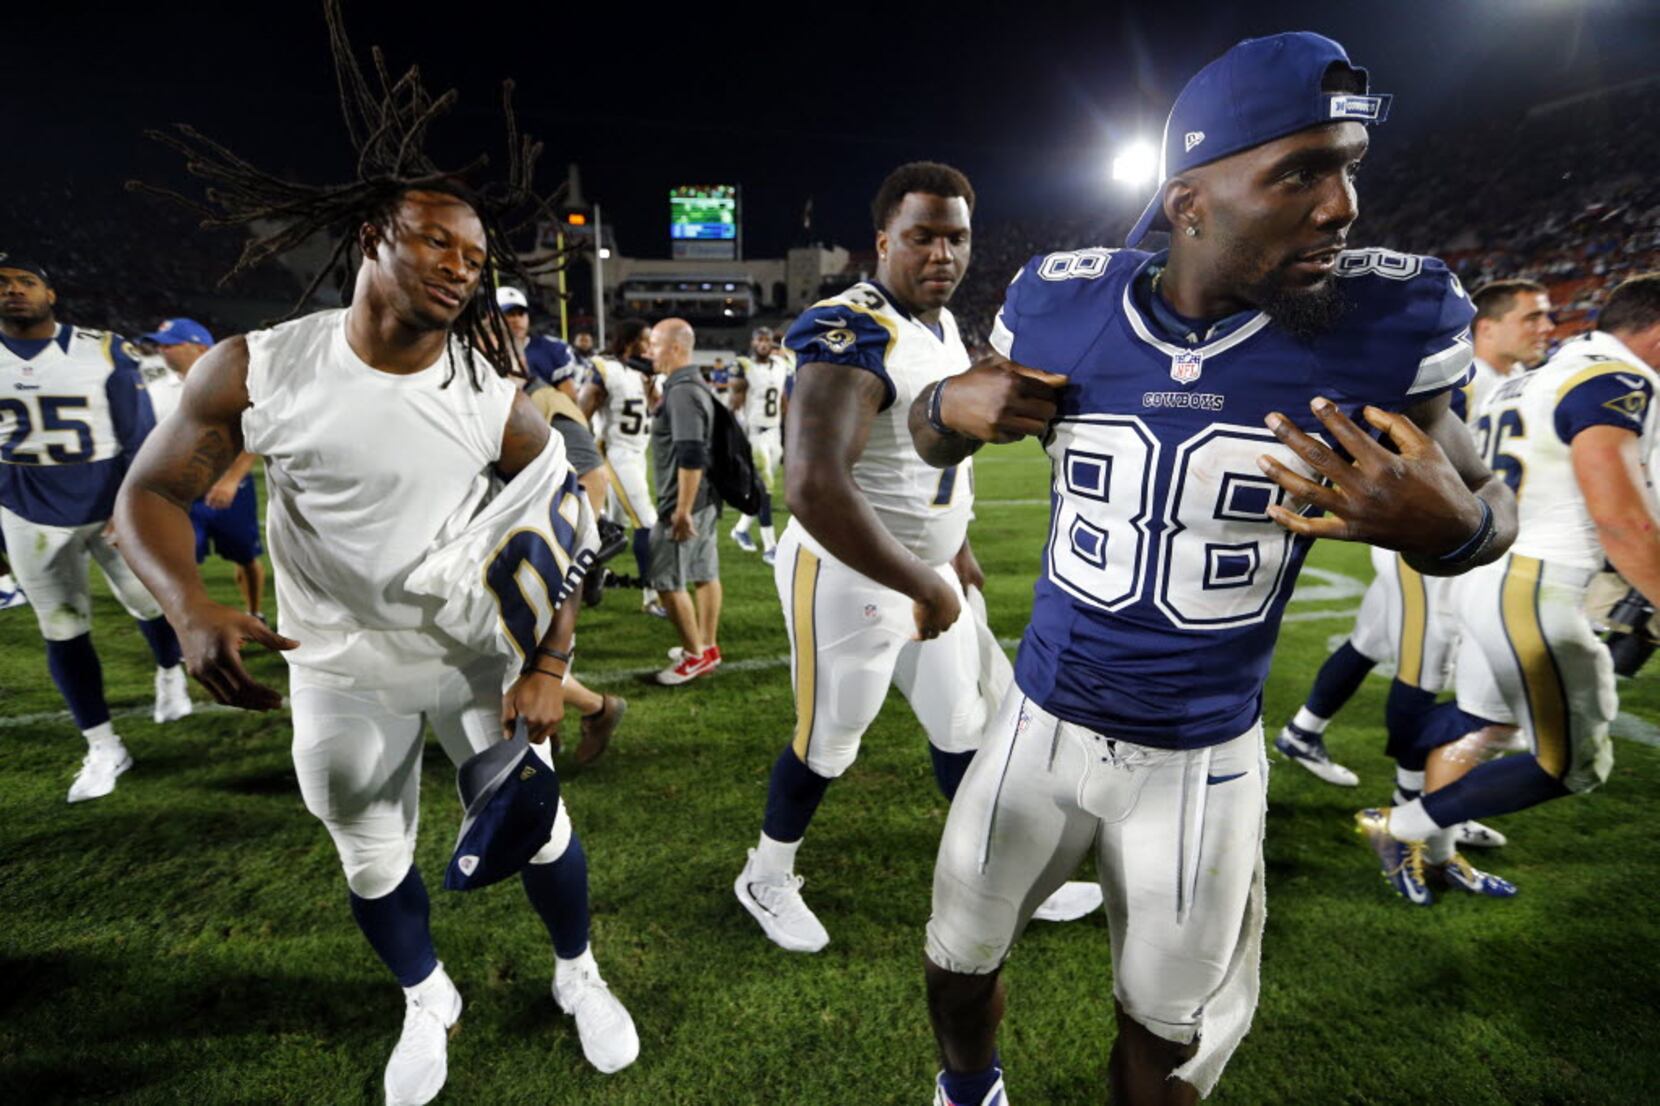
[578, 319, 662, 613]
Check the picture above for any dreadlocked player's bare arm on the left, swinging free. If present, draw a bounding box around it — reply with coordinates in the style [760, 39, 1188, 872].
[115, 337, 299, 711]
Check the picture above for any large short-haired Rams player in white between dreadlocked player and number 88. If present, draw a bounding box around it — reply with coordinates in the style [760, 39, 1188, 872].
[734, 161, 1099, 952]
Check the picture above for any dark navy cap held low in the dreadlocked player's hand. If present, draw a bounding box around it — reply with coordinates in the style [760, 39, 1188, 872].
[443, 719, 559, 890]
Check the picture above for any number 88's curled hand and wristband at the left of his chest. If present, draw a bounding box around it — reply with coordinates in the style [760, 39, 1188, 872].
[908, 354, 1066, 468]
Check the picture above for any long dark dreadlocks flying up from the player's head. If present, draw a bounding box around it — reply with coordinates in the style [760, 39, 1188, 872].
[126, 0, 574, 389]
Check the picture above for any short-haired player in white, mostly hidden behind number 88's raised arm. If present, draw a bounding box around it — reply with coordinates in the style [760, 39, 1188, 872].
[1273, 281, 1552, 830]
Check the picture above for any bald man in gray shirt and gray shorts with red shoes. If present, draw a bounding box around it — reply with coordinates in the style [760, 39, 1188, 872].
[647, 319, 720, 684]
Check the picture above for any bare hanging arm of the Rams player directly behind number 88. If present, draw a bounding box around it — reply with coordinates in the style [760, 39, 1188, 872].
[784, 362, 959, 639]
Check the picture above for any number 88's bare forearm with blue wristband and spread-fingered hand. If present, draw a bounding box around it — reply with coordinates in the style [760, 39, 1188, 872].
[1258, 394, 1516, 576]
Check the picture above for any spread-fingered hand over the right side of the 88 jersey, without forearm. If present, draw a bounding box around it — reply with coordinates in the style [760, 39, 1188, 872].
[1257, 395, 1486, 556]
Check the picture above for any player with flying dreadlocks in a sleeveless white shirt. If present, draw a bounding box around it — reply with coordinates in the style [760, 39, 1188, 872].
[116, 0, 639, 1104]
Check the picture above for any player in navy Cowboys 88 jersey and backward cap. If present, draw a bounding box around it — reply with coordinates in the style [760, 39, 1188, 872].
[910, 33, 1516, 1106]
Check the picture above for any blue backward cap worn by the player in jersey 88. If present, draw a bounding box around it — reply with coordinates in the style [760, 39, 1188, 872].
[1124, 32, 1393, 246]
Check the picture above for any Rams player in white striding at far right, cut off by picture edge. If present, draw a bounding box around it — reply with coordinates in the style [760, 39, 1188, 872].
[1356, 274, 1660, 905]
